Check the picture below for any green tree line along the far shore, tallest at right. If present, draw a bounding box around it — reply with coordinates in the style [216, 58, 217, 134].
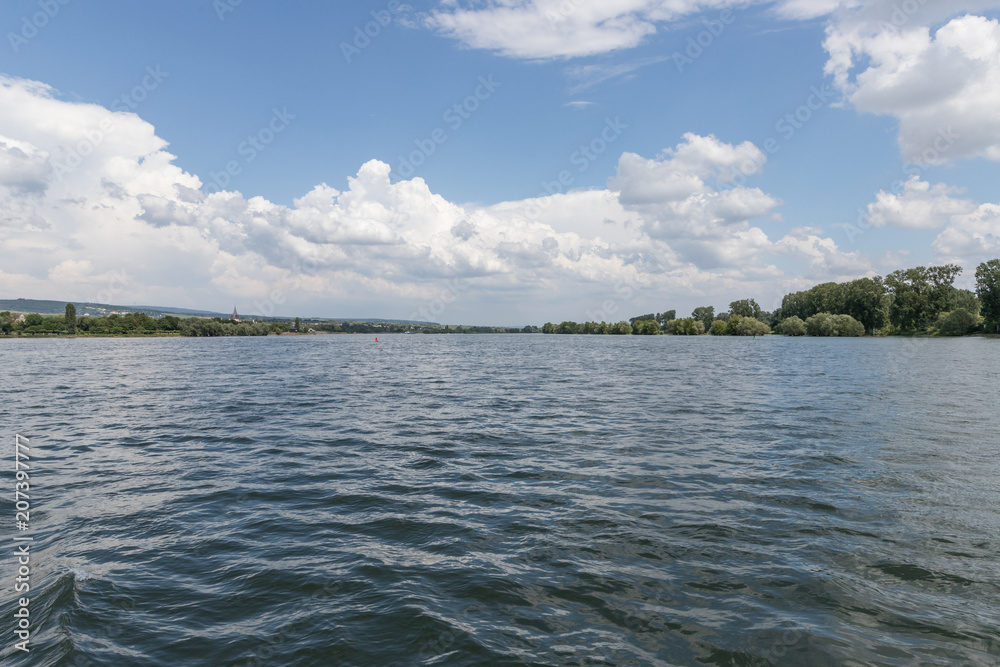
[0, 259, 1000, 337]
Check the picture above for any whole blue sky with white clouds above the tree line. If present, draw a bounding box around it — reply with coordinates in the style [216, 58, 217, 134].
[0, 0, 1000, 324]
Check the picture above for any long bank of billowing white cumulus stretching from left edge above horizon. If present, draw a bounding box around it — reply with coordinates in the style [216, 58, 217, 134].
[0, 72, 884, 323]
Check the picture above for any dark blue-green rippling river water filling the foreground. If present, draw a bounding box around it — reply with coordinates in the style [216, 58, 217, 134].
[0, 335, 1000, 666]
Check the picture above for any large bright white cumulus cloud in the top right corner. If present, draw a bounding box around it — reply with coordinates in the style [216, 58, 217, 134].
[825, 8, 1000, 164]
